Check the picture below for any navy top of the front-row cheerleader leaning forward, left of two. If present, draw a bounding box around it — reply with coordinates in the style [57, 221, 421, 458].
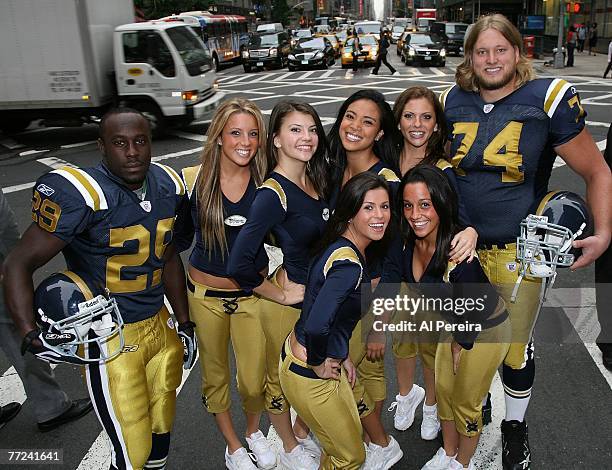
[295, 237, 369, 366]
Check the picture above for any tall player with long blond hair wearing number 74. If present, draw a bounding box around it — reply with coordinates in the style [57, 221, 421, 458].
[440, 15, 612, 469]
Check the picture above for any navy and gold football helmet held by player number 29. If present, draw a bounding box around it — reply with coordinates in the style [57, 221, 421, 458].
[34, 271, 124, 363]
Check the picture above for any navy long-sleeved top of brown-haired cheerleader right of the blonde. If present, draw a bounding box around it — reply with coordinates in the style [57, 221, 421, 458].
[228, 171, 329, 289]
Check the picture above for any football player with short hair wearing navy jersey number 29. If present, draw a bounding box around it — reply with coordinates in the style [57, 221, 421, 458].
[5, 108, 196, 469]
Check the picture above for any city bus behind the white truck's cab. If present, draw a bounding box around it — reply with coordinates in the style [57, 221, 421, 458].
[162, 11, 249, 71]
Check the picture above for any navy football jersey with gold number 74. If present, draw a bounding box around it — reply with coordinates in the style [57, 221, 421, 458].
[440, 79, 586, 243]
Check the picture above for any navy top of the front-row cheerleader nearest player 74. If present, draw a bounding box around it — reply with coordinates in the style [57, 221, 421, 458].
[376, 240, 508, 349]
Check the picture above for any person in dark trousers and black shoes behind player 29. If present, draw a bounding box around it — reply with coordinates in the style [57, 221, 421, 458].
[0, 190, 93, 432]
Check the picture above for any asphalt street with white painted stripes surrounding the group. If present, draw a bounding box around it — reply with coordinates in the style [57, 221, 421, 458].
[0, 48, 612, 470]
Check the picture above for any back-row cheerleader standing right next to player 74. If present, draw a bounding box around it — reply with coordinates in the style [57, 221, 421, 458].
[382, 86, 478, 440]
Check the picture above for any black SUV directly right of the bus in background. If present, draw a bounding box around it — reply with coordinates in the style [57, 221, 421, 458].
[242, 31, 291, 72]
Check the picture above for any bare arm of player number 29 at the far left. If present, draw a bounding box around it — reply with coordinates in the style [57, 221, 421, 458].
[4, 224, 66, 337]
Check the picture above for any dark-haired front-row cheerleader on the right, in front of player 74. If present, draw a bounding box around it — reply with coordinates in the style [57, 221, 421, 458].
[390, 165, 511, 469]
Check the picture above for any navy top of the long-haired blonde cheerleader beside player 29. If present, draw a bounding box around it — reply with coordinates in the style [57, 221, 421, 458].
[176, 165, 268, 277]
